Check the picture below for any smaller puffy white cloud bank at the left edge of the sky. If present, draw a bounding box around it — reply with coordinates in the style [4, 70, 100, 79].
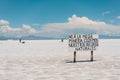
[0, 20, 37, 37]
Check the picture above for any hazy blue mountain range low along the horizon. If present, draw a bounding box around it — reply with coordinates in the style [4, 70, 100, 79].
[0, 35, 120, 40]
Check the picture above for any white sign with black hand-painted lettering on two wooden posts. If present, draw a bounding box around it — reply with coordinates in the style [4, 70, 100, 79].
[68, 34, 98, 62]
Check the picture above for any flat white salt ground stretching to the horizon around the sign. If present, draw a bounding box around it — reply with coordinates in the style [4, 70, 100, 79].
[0, 39, 120, 80]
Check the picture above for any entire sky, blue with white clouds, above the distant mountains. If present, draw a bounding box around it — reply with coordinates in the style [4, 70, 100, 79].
[0, 0, 120, 38]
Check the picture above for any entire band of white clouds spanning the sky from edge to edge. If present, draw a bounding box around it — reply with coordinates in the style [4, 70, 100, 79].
[0, 15, 120, 37]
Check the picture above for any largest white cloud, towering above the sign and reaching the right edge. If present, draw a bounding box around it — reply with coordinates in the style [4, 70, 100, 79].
[44, 15, 120, 35]
